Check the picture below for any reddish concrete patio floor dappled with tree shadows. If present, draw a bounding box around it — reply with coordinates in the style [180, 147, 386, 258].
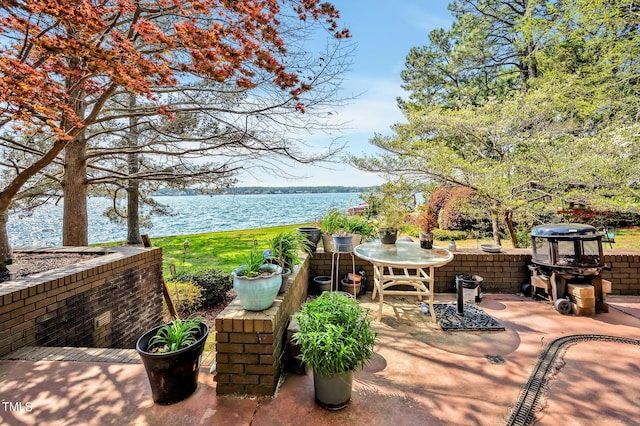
[0, 294, 640, 425]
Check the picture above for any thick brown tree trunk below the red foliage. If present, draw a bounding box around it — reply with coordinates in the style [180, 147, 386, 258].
[62, 132, 89, 246]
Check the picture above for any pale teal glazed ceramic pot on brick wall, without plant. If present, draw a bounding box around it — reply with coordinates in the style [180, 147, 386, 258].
[231, 264, 282, 311]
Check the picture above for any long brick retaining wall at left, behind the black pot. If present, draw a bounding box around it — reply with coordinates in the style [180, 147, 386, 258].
[0, 247, 162, 356]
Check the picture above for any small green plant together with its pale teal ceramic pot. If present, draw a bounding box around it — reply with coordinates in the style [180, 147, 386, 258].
[231, 251, 282, 311]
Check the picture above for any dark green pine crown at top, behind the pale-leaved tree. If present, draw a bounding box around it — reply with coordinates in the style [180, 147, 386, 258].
[400, 0, 552, 108]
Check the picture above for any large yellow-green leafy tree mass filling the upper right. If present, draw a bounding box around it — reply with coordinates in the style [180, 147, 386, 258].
[352, 0, 640, 246]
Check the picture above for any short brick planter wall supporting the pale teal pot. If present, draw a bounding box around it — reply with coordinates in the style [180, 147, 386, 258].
[215, 253, 310, 395]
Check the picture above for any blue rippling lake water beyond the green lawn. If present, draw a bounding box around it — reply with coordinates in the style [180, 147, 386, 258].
[7, 193, 361, 247]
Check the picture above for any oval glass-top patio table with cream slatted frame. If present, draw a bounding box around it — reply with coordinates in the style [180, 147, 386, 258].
[353, 241, 453, 323]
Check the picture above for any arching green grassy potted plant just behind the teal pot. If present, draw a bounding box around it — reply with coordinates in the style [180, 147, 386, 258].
[269, 231, 313, 293]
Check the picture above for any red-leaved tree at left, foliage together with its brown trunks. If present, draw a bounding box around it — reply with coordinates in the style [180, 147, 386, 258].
[0, 0, 348, 265]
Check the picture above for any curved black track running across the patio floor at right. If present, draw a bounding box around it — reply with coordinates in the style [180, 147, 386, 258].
[507, 334, 640, 426]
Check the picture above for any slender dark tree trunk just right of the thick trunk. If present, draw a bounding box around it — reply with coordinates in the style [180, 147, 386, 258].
[127, 94, 142, 244]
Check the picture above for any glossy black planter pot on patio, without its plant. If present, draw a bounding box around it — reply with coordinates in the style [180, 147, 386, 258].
[136, 323, 209, 405]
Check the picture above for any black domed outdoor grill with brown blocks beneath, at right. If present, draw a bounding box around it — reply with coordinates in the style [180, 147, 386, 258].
[529, 223, 611, 316]
